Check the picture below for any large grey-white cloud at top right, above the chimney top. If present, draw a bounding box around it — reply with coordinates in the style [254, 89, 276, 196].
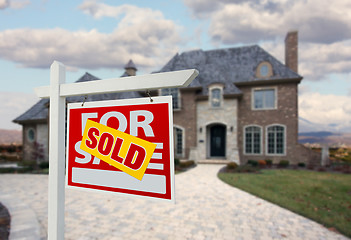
[184, 0, 351, 44]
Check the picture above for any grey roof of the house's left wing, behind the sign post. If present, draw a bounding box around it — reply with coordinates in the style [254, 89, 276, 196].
[13, 72, 142, 124]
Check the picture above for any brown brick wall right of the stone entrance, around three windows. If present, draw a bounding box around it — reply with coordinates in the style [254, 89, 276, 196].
[238, 83, 318, 164]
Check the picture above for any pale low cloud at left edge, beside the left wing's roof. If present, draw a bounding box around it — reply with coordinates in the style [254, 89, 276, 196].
[0, 92, 39, 129]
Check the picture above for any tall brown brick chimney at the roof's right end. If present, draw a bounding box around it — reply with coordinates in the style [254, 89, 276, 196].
[285, 31, 298, 73]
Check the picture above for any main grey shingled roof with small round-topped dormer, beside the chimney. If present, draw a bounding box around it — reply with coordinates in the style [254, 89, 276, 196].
[159, 45, 302, 95]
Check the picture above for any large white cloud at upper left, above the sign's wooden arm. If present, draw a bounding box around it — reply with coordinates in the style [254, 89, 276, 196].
[0, 1, 181, 69]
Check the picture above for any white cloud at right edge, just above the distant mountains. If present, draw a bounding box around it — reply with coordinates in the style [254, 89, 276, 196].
[299, 92, 351, 132]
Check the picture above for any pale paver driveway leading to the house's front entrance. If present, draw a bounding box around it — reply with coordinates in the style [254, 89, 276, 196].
[0, 164, 347, 240]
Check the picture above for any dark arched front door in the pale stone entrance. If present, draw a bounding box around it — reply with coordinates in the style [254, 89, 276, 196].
[210, 125, 226, 157]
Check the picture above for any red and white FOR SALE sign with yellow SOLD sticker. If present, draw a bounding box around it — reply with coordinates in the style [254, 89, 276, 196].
[66, 96, 174, 201]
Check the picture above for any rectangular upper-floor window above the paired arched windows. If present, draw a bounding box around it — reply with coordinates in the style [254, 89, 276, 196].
[253, 88, 276, 110]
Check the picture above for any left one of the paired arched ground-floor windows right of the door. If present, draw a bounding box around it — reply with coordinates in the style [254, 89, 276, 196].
[244, 126, 262, 154]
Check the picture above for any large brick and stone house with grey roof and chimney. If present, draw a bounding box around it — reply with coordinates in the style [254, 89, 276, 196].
[14, 31, 318, 164]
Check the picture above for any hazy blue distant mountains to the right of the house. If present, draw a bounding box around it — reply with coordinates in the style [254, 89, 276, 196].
[299, 131, 351, 146]
